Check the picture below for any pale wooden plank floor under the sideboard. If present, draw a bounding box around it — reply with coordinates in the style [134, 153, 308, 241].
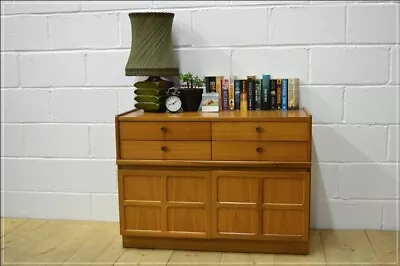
[1, 218, 400, 266]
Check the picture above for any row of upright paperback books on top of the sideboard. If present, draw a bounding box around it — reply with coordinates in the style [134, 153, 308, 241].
[204, 74, 299, 111]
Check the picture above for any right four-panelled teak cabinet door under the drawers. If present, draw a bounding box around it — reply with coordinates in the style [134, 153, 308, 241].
[212, 171, 310, 240]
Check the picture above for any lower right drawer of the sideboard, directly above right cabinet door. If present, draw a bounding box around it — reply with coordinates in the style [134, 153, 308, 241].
[212, 141, 308, 162]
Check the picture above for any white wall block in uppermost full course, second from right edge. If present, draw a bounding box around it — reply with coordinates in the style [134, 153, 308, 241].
[268, 6, 346, 44]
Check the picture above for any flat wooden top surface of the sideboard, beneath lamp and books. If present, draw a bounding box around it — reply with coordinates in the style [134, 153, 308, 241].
[117, 108, 311, 121]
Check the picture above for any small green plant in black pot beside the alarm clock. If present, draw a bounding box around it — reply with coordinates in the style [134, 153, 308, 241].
[179, 72, 204, 112]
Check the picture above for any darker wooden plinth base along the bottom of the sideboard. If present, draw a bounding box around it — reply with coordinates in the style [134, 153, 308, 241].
[122, 236, 309, 255]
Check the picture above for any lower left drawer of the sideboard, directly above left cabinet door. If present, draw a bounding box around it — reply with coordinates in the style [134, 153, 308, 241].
[120, 141, 211, 160]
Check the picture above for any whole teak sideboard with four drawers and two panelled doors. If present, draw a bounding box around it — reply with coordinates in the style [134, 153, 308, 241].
[115, 109, 312, 254]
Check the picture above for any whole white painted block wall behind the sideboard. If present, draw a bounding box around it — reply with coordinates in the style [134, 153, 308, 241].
[1, 1, 400, 230]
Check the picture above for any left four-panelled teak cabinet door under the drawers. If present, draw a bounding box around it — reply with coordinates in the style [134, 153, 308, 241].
[119, 169, 211, 238]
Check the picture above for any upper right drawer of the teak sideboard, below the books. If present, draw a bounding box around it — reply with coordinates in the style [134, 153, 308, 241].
[212, 122, 309, 141]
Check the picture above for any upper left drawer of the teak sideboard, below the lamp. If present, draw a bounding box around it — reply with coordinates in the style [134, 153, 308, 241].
[119, 121, 211, 140]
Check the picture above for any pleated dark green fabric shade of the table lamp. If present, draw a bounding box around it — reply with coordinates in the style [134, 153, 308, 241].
[125, 12, 179, 76]
